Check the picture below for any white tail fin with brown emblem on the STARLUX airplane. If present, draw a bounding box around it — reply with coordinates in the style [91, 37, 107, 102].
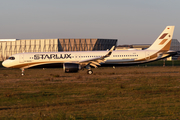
[147, 26, 174, 52]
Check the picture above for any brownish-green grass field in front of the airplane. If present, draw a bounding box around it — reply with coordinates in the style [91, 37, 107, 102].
[0, 67, 180, 120]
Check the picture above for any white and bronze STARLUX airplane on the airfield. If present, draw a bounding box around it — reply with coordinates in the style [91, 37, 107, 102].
[2, 26, 177, 75]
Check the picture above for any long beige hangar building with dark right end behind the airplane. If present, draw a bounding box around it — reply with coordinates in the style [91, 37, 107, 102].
[0, 38, 117, 61]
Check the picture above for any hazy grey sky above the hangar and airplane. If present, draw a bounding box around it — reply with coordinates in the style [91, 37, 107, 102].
[0, 0, 180, 45]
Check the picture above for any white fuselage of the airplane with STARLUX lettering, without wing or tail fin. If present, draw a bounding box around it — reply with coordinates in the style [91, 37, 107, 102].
[3, 50, 174, 68]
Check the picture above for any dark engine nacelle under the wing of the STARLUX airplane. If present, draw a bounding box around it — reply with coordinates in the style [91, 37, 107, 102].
[63, 63, 81, 73]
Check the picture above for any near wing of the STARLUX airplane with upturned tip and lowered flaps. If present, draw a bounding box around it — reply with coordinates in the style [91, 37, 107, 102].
[79, 46, 115, 68]
